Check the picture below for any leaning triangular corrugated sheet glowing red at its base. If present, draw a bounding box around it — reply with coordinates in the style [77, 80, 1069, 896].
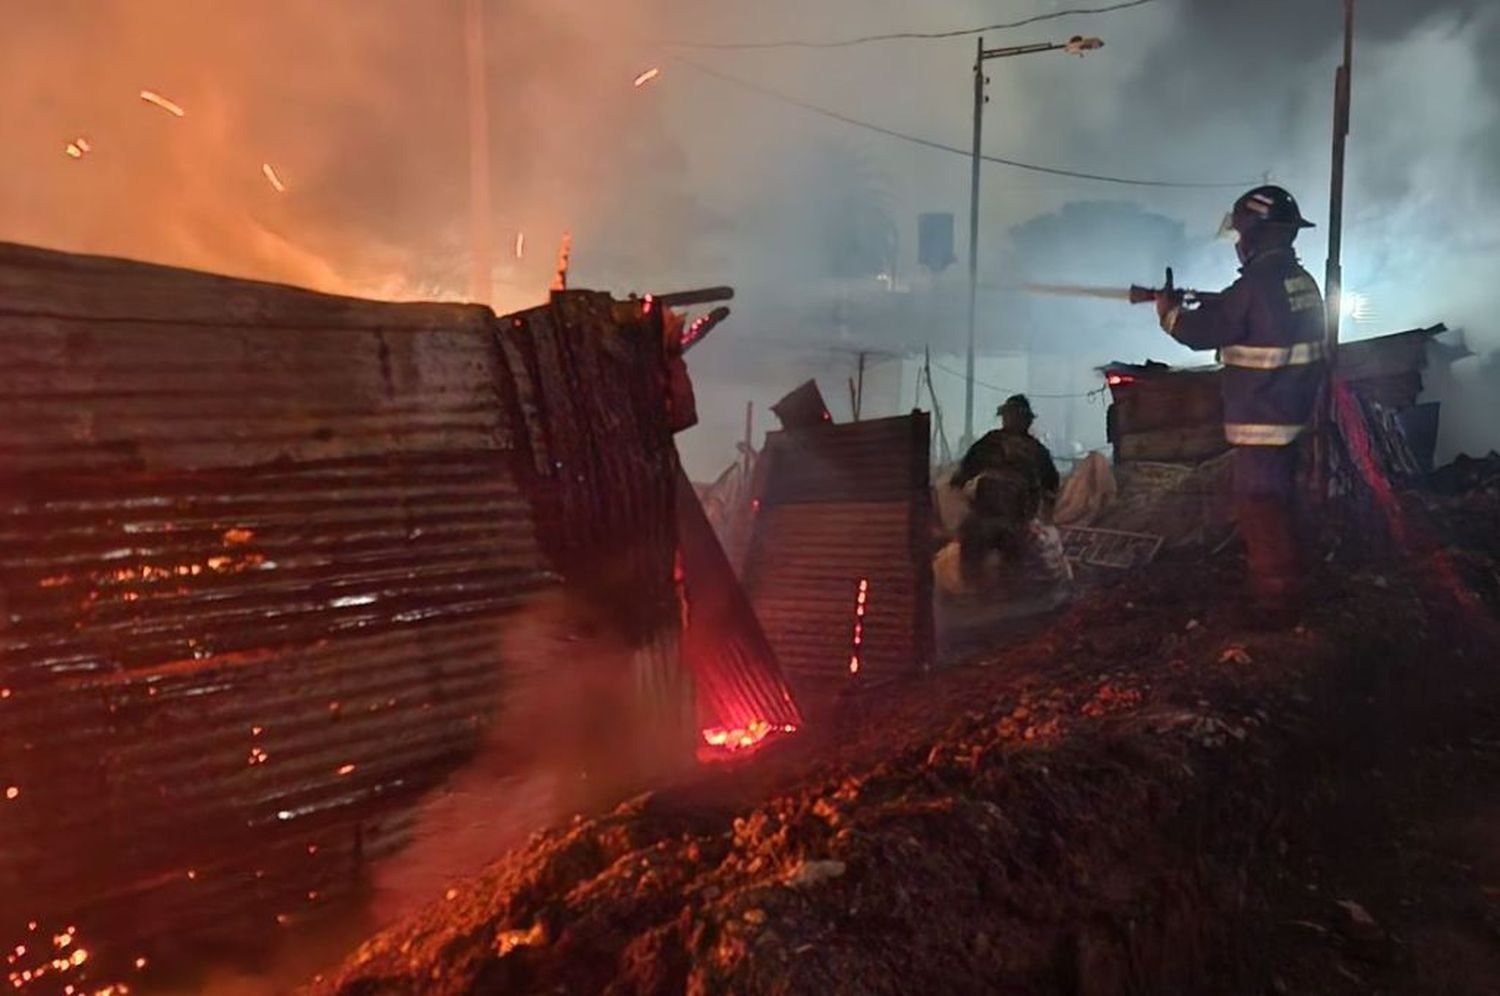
[677, 462, 803, 731]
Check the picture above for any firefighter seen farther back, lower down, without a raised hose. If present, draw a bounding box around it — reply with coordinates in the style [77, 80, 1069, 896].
[948, 395, 1059, 585]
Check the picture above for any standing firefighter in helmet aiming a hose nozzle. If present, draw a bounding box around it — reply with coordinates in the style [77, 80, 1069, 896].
[1157, 186, 1328, 621]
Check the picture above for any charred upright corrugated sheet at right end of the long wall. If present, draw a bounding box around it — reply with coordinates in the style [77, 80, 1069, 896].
[500, 291, 698, 767]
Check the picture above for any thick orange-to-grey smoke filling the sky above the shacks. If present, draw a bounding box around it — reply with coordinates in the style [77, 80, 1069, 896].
[0, 0, 1500, 477]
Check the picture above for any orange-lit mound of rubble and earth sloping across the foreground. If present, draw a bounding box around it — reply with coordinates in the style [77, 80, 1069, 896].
[314, 468, 1500, 996]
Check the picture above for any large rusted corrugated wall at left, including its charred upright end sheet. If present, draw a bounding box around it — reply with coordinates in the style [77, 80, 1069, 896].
[0, 246, 686, 978]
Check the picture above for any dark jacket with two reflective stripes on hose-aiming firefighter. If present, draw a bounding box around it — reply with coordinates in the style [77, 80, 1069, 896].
[1163, 248, 1326, 446]
